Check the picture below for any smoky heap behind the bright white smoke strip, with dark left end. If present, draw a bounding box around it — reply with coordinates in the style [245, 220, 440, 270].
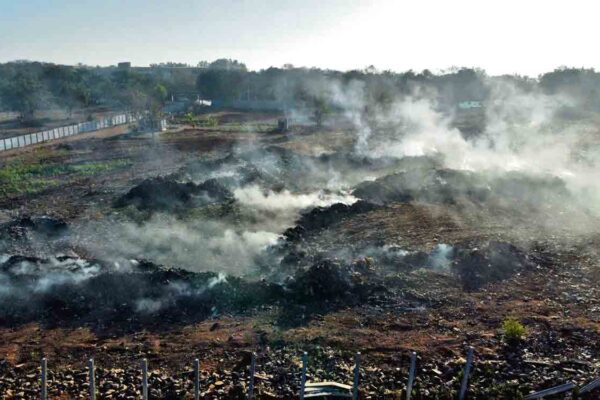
[114, 146, 404, 211]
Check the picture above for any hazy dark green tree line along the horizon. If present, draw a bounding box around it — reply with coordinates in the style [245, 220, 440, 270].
[0, 59, 600, 120]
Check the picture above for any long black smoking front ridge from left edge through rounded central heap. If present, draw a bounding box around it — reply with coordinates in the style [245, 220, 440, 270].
[0, 250, 390, 328]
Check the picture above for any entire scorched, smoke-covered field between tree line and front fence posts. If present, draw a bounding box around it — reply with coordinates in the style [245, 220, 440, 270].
[0, 86, 600, 399]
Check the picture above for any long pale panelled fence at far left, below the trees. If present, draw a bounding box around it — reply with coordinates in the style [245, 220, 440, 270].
[0, 114, 138, 152]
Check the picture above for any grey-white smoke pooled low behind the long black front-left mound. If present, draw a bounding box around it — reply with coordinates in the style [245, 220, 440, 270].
[77, 214, 279, 275]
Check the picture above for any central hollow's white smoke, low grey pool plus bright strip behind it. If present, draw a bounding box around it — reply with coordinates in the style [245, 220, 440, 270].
[75, 185, 356, 275]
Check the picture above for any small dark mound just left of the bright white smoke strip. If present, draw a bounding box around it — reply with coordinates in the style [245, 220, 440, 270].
[115, 177, 233, 211]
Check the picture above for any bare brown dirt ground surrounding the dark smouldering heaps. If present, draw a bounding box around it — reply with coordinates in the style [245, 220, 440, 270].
[0, 111, 600, 399]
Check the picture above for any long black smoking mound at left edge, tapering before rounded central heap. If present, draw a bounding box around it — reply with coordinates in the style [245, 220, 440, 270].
[0, 256, 283, 326]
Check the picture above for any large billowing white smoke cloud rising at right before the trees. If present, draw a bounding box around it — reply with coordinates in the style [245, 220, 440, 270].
[312, 77, 600, 222]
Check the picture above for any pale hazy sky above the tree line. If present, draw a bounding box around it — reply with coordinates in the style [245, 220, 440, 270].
[0, 0, 600, 75]
